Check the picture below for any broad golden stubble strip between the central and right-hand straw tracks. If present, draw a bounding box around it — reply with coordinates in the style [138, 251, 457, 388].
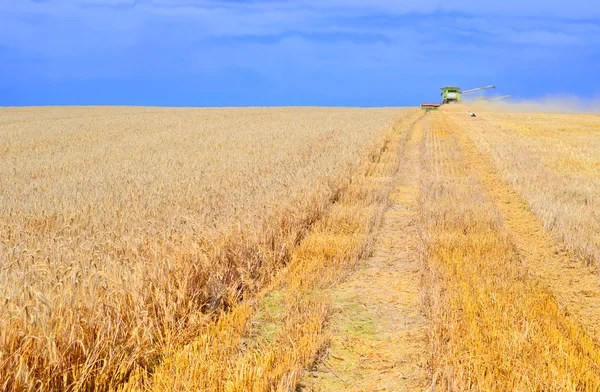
[422, 112, 600, 391]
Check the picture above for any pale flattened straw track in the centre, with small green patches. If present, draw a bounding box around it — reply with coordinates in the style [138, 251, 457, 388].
[300, 115, 429, 391]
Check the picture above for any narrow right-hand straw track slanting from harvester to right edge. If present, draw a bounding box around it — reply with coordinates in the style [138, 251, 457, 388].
[446, 112, 600, 342]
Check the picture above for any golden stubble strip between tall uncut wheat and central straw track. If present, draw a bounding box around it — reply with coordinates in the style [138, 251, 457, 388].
[123, 109, 418, 392]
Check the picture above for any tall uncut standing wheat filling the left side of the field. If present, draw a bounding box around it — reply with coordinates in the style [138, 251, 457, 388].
[0, 108, 410, 390]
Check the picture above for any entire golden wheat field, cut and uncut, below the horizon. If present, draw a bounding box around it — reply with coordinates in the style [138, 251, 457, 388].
[0, 105, 600, 392]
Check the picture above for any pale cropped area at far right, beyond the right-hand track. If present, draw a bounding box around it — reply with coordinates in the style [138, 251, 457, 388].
[446, 112, 600, 268]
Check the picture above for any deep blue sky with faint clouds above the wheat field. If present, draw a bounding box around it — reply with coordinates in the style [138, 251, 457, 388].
[0, 0, 600, 106]
